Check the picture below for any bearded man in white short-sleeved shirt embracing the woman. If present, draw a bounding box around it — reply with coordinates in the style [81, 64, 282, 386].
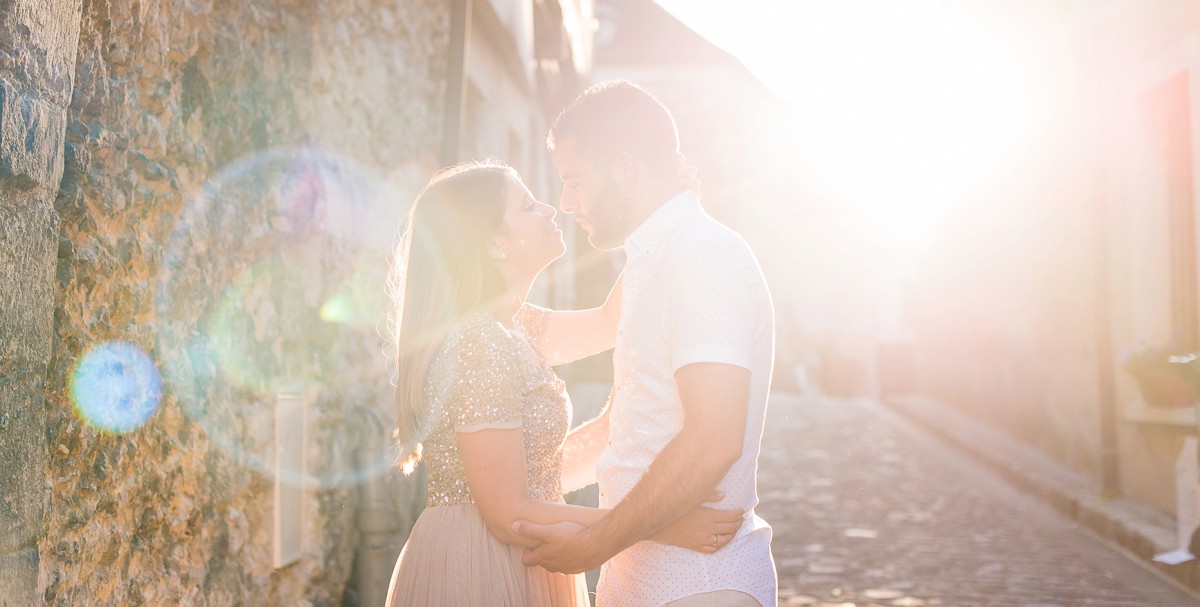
[514, 82, 776, 607]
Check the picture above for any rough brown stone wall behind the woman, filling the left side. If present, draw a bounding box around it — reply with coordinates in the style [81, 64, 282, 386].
[0, 0, 449, 605]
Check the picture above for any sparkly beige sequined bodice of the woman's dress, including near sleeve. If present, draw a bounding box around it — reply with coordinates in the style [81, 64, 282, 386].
[422, 307, 571, 506]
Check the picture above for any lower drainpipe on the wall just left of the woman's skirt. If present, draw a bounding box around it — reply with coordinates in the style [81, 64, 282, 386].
[350, 405, 401, 606]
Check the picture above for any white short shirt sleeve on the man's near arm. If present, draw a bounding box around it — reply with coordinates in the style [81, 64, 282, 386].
[666, 240, 761, 372]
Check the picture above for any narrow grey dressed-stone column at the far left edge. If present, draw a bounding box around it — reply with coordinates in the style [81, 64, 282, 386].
[0, 0, 79, 606]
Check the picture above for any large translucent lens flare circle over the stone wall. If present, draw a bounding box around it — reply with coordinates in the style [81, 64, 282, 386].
[156, 144, 410, 487]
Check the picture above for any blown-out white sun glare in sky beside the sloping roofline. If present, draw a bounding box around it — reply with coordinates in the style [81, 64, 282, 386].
[660, 0, 1054, 247]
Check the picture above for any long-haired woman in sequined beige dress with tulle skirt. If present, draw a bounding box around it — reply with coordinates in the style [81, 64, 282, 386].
[388, 161, 742, 607]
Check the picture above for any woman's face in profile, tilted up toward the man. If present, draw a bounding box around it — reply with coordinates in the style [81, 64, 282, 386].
[496, 175, 566, 274]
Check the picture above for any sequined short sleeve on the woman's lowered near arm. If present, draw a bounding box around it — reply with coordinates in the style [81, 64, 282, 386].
[445, 319, 524, 432]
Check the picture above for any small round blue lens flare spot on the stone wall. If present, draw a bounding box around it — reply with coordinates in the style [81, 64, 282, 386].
[71, 342, 162, 433]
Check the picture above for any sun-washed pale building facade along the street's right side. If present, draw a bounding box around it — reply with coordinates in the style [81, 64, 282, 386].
[905, 0, 1200, 544]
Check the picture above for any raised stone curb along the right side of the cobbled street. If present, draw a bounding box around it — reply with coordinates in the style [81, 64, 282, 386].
[882, 395, 1200, 593]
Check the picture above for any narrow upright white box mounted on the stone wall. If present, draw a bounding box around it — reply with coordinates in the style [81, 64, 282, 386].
[271, 393, 308, 569]
